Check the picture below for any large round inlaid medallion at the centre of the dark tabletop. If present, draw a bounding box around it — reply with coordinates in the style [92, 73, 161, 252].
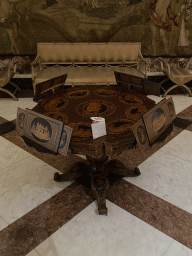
[75, 100, 116, 117]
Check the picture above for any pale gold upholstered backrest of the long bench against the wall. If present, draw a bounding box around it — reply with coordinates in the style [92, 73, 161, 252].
[37, 42, 141, 64]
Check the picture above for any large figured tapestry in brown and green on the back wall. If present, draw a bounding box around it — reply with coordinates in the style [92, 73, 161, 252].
[0, 0, 192, 56]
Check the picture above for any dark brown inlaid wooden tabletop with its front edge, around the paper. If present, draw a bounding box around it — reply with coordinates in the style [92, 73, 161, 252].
[33, 86, 155, 158]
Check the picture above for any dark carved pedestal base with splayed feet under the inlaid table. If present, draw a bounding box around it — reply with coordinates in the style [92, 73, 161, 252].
[54, 155, 141, 214]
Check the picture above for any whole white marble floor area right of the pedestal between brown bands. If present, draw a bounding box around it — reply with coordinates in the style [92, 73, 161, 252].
[124, 131, 192, 214]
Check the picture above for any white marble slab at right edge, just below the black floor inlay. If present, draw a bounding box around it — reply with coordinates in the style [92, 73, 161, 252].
[160, 130, 192, 162]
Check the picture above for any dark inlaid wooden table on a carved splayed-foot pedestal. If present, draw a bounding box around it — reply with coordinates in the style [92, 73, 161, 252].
[33, 86, 155, 214]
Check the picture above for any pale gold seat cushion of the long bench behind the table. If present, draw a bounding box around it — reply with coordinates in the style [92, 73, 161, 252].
[34, 66, 145, 85]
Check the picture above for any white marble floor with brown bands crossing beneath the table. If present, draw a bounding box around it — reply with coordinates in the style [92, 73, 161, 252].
[0, 95, 192, 256]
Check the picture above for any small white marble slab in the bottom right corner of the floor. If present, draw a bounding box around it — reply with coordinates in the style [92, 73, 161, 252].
[163, 241, 192, 256]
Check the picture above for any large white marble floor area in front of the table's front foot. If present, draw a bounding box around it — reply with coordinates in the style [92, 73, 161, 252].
[35, 201, 173, 256]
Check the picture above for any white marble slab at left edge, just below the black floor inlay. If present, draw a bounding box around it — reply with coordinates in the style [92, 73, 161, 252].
[0, 136, 31, 171]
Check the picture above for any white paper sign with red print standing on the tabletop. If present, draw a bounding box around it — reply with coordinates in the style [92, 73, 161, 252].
[91, 117, 107, 139]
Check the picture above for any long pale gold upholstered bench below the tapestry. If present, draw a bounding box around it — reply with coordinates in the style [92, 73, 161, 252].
[32, 43, 147, 93]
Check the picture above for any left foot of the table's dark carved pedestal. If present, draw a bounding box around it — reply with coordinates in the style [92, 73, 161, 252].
[54, 162, 90, 182]
